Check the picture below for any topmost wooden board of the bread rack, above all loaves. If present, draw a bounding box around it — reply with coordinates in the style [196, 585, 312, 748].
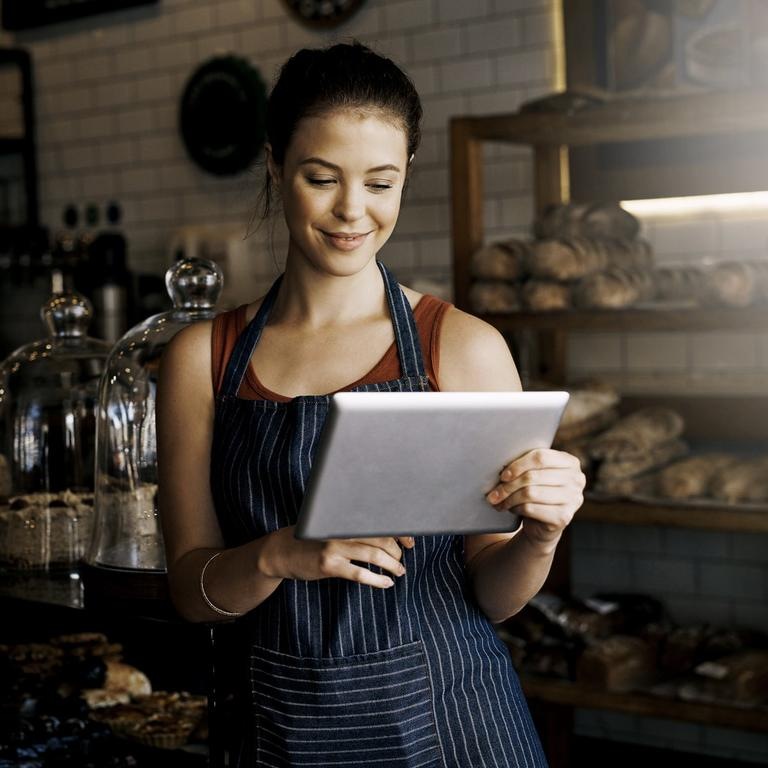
[453, 89, 768, 146]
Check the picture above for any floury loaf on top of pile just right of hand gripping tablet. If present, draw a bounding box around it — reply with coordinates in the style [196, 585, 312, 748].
[589, 406, 685, 461]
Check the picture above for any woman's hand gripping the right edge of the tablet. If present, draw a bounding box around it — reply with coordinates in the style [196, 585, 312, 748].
[486, 448, 587, 544]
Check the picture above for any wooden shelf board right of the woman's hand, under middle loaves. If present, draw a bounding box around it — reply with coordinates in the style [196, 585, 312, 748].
[575, 498, 768, 533]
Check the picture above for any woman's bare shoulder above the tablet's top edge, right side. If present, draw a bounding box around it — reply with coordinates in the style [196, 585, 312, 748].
[439, 307, 522, 392]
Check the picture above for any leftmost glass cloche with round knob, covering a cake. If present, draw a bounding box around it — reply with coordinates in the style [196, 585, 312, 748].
[0, 292, 110, 571]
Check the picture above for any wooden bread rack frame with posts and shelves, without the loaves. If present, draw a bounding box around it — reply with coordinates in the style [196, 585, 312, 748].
[451, 90, 768, 768]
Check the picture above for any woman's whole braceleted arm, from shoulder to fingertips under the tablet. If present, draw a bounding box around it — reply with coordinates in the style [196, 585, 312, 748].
[157, 323, 413, 621]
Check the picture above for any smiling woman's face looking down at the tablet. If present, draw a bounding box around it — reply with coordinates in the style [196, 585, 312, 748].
[270, 110, 408, 275]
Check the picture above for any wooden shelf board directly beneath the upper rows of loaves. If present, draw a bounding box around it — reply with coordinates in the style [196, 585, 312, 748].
[480, 306, 768, 332]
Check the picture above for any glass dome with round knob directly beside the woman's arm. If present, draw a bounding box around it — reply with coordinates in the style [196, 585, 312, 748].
[86, 258, 223, 572]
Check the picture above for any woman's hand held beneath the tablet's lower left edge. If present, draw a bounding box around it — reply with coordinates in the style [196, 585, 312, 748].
[259, 526, 414, 589]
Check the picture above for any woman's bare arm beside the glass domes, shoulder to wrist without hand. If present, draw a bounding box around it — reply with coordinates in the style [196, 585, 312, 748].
[157, 323, 281, 621]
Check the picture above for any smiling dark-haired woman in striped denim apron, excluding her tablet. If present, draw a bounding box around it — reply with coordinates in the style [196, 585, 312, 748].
[158, 44, 584, 768]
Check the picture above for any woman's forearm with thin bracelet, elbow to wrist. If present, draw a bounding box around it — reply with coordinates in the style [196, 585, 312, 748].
[168, 536, 282, 622]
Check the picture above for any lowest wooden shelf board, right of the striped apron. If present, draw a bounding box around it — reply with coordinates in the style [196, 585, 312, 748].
[521, 677, 768, 732]
